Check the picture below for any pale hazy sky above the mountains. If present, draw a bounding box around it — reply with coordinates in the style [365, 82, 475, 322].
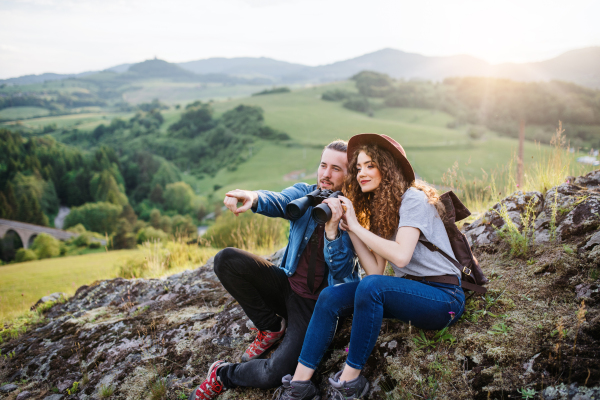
[0, 0, 600, 79]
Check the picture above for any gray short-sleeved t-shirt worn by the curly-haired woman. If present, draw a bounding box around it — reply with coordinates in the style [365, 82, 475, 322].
[390, 188, 460, 278]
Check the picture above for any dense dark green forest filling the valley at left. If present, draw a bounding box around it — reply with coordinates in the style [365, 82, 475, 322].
[0, 101, 289, 261]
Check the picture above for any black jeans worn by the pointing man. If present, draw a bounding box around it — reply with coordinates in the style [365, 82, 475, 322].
[214, 247, 316, 389]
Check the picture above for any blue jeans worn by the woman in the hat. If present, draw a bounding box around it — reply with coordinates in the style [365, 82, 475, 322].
[298, 275, 465, 369]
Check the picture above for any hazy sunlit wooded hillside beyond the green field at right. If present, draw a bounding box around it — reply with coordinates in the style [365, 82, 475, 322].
[322, 71, 600, 149]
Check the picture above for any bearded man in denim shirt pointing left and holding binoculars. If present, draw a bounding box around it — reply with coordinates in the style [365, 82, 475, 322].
[189, 140, 360, 400]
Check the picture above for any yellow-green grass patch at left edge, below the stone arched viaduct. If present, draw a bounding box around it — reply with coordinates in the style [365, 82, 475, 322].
[0, 250, 139, 321]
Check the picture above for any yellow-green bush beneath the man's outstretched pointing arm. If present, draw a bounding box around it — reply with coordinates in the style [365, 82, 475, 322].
[204, 212, 289, 253]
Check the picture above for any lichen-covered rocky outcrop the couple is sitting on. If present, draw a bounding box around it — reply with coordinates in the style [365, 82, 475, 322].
[0, 171, 600, 400]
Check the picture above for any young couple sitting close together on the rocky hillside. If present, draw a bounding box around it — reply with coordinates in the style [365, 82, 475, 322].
[189, 133, 465, 400]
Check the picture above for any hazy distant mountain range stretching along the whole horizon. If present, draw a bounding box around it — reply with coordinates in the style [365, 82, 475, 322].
[0, 47, 600, 88]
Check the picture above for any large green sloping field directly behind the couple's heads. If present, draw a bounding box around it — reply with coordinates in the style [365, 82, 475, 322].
[200, 82, 552, 198]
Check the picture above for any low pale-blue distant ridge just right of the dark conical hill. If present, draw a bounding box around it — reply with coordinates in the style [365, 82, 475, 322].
[177, 57, 302, 79]
